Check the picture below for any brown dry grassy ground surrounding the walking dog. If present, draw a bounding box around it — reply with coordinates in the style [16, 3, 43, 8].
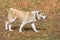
[0, 0, 60, 40]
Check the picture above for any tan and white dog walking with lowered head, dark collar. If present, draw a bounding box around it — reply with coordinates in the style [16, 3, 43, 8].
[5, 8, 46, 32]
